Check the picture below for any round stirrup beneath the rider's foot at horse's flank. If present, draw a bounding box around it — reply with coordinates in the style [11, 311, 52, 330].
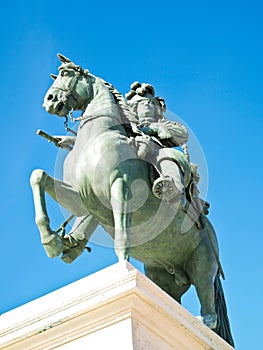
[152, 176, 181, 202]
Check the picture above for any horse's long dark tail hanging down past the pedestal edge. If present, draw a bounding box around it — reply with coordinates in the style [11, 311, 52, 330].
[214, 274, 234, 347]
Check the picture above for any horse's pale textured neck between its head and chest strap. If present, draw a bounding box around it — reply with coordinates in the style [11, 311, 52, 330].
[83, 77, 119, 118]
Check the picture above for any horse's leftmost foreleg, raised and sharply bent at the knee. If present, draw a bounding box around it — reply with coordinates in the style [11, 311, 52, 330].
[30, 169, 87, 258]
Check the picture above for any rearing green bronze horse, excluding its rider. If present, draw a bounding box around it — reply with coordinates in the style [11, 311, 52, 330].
[31, 55, 233, 345]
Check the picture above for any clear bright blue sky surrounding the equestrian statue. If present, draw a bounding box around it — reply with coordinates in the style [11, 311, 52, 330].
[0, 0, 263, 350]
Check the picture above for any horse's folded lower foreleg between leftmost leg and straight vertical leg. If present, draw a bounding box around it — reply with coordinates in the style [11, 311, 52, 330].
[61, 214, 98, 263]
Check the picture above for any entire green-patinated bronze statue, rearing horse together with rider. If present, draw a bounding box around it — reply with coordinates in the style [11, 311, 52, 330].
[31, 55, 233, 345]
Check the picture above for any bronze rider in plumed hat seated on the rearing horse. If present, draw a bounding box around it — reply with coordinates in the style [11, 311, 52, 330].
[125, 82, 209, 228]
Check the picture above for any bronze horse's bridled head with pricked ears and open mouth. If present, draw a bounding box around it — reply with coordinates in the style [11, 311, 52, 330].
[43, 54, 89, 117]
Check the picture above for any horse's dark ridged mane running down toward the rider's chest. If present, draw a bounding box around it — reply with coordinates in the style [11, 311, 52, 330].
[103, 81, 138, 125]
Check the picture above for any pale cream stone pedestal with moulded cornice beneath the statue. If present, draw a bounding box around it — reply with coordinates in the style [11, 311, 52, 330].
[0, 261, 232, 350]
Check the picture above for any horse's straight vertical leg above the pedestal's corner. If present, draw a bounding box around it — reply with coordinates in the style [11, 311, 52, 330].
[111, 177, 132, 261]
